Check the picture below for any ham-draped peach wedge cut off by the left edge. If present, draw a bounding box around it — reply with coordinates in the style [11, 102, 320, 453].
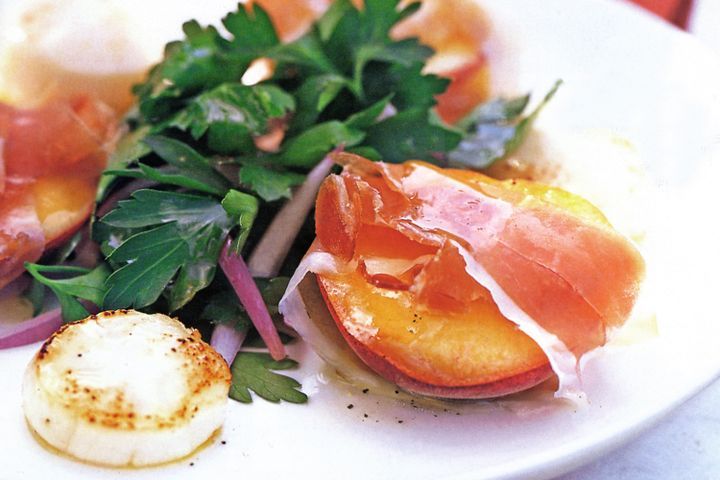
[0, 96, 116, 288]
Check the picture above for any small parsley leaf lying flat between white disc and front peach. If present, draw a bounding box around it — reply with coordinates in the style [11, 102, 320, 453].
[230, 352, 307, 403]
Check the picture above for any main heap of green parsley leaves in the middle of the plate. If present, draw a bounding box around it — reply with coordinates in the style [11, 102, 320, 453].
[81, 0, 460, 319]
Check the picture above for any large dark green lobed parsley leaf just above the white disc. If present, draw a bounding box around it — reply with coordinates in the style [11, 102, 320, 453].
[101, 190, 239, 312]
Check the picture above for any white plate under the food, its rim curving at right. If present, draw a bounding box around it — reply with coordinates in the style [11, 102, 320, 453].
[0, 0, 720, 479]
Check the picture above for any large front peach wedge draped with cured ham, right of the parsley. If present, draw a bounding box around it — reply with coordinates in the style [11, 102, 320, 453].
[282, 154, 644, 398]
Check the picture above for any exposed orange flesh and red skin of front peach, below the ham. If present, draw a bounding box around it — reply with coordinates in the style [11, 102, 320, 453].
[317, 273, 553, 399]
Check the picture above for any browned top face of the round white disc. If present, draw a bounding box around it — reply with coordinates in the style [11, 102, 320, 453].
[33, 310, 231, 430]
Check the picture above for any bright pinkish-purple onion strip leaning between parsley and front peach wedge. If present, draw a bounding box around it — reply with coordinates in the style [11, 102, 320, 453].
[219, 238, 286, 360]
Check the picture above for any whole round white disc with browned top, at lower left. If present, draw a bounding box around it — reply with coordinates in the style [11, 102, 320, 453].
[23, 310, 231, 466]
